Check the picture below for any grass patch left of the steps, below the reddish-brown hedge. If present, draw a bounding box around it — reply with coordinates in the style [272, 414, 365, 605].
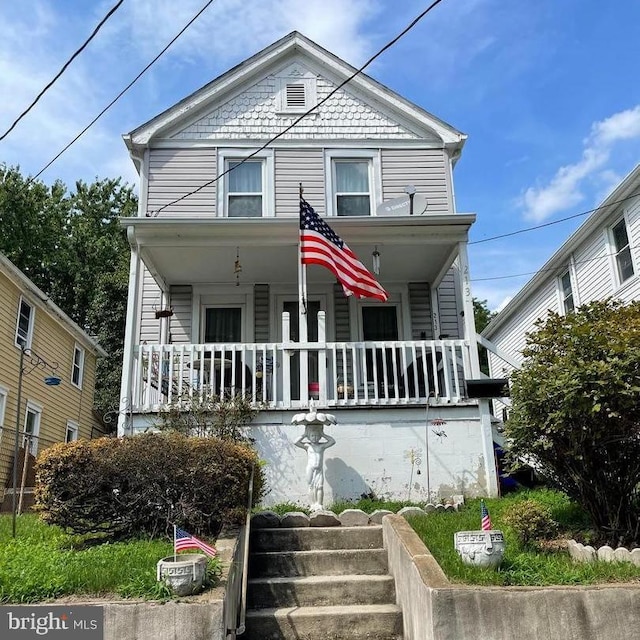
[0, 514, 218, 603]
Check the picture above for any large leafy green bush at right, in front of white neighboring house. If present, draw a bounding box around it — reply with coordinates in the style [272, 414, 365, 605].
[505, 300, 640, 545]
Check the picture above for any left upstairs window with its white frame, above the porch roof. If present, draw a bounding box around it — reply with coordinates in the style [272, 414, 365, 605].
[218, 149, 273, 218]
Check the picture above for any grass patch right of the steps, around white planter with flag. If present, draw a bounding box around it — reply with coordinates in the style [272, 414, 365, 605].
[408, 489, 640, 586]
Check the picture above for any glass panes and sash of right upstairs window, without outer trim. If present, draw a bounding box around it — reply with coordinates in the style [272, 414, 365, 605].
[333, 158, 372, 216]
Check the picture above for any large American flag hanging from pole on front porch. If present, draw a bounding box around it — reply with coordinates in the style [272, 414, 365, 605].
[300, 199, 389, 302]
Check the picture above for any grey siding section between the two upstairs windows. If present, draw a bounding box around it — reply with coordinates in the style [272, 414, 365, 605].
[275, 149, 325, 217]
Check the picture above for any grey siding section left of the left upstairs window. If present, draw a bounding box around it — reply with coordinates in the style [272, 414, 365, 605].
[147, 148, 217, 217]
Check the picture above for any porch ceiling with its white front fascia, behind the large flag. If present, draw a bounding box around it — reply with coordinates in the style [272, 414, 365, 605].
[121, 214, 475, 286]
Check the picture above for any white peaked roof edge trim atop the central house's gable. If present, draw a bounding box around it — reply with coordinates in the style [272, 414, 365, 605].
[123, 31, 467, 159]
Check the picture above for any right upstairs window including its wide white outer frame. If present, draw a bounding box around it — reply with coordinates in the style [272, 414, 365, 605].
[325, 149, 382, 216]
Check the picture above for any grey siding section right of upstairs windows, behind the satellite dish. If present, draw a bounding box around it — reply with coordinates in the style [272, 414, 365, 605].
[382, 149, 453, 214]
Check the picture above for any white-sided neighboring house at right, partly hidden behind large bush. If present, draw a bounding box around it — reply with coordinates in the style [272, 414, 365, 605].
[482, 165, 640, 414]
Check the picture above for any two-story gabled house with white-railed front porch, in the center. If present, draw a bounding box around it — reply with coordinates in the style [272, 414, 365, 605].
[119, 32, 497, 502]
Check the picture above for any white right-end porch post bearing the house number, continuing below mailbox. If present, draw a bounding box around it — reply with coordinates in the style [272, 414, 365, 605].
[458, 242, 498, 496]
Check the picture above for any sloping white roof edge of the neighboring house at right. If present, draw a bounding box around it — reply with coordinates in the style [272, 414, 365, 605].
[482, 164, 640, 338]
